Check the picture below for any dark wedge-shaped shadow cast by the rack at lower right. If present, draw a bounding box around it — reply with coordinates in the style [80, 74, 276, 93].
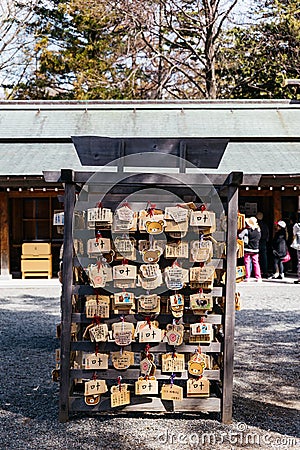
[233, 395, 300, 438]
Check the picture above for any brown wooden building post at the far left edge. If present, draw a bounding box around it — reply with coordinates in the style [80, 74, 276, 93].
[0, 192, 11, 279]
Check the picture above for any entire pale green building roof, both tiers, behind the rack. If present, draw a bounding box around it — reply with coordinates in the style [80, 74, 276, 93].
[0, 100, 300, 175]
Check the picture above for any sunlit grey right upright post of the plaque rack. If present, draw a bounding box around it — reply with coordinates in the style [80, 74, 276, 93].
[222, 178, 238, 423]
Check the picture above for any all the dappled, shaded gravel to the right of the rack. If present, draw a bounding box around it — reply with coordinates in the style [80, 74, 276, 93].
[234, 304, 300, 437]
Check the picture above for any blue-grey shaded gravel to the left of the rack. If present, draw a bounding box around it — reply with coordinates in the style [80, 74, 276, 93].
[0, 306, 59, 420]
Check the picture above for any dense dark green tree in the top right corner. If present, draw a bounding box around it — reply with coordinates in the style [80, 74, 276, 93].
[218, 1, 300, 99]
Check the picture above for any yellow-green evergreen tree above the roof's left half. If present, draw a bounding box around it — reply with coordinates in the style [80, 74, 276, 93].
[10, 1, 154, 99]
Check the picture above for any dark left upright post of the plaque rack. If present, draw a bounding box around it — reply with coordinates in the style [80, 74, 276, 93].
[59, 170, 75, 422]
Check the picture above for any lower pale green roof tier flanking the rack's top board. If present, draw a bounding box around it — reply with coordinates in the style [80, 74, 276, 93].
[0, 143, 300, 176]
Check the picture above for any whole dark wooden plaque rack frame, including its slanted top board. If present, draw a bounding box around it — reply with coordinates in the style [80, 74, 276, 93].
[44, 136, 259, 423]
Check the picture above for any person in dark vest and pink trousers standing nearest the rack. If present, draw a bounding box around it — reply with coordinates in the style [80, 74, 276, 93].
[239, 217, 261, 282]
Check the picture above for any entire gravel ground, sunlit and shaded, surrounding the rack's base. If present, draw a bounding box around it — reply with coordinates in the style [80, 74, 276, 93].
[0, 280, 300, 450]
